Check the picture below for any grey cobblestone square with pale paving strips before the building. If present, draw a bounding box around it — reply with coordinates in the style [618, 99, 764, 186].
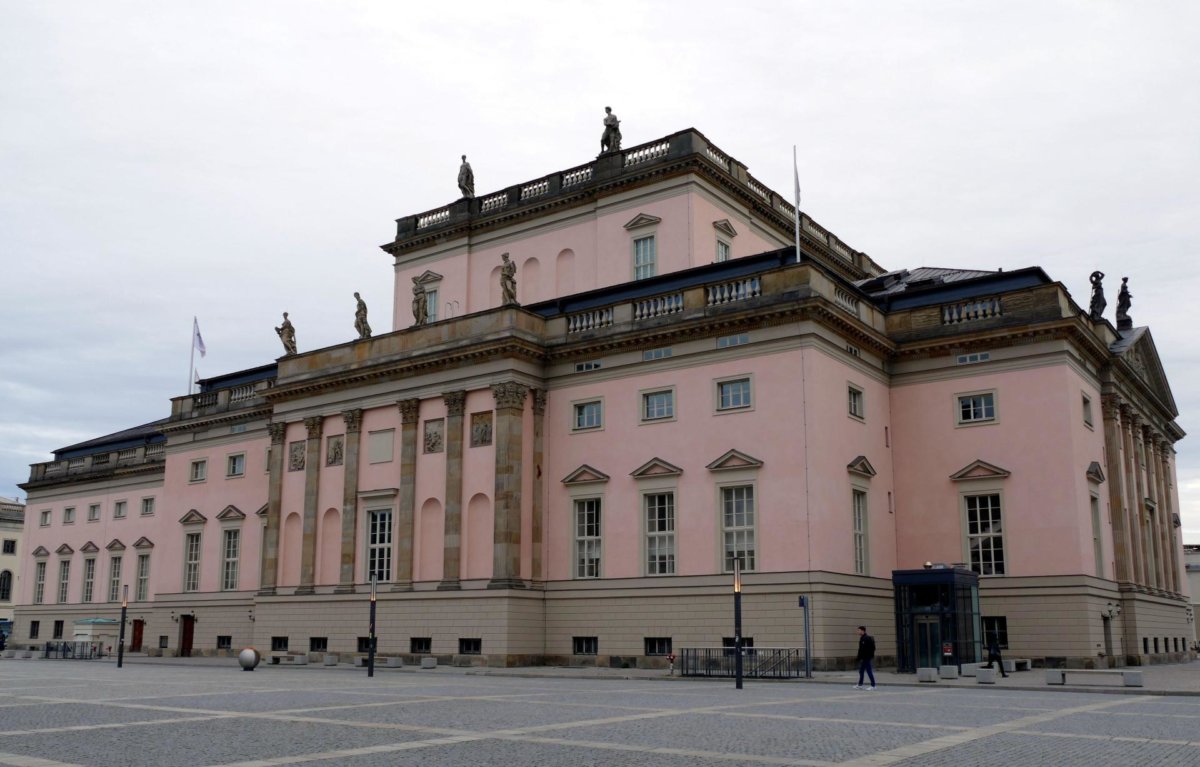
[0, 659, 1200, 767]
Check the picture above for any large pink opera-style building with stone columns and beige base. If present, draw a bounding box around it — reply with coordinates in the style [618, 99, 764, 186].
[14, 130, 1194, 667]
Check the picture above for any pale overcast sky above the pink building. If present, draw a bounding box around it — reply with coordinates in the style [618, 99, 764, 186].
[0, 0, 1200, 543]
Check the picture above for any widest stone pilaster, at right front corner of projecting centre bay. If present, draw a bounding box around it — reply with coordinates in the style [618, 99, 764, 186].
[487, 380, 529, 588]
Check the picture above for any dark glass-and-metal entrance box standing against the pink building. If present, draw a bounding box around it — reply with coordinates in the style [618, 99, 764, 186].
[892, 564, 983, 673]
